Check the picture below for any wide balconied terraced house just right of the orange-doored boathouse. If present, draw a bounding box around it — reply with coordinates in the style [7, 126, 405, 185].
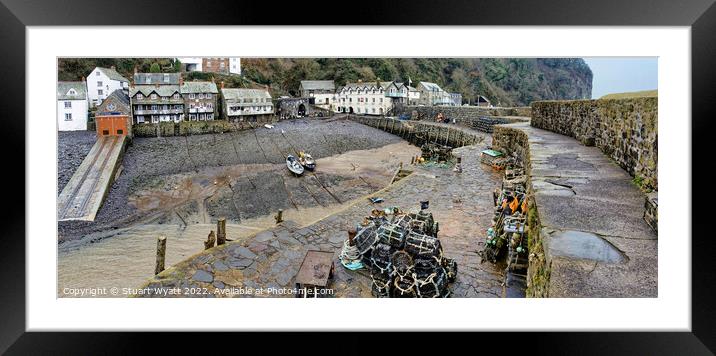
[129, 73, 184, 124]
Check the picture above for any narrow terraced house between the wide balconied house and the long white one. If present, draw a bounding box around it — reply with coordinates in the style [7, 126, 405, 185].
[179, 82, 219, 121]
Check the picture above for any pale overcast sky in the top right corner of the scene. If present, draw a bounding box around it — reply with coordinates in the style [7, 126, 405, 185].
[584, 57, 658, 99]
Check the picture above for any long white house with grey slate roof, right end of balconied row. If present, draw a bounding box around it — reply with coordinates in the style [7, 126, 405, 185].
[221, 88, 274, 123]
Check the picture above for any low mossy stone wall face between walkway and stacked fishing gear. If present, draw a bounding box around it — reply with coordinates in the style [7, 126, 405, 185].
[492, 125, 550, 298]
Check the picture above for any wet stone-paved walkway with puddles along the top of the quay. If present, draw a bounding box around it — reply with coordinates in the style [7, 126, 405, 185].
[502, 123, 658, 297]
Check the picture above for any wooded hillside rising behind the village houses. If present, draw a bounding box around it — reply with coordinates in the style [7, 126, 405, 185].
[58, 58, 592, 106]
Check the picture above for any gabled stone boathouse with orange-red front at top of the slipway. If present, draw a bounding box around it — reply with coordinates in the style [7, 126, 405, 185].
[95, 89, 132, 137]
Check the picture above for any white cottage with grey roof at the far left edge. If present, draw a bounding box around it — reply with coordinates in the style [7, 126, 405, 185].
[57, 82, 88, 131]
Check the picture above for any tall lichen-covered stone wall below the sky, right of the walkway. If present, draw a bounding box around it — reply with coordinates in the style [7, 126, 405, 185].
[531, 97, 658, 191]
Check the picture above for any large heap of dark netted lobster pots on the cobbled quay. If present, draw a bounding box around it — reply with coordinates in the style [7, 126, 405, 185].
[355, 211, 457, 298]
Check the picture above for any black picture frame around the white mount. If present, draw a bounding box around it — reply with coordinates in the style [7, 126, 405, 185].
[0, 0, 716, 355]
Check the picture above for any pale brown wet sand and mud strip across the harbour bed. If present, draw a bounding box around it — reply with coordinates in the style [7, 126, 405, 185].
[58, 141, 419, 297]
